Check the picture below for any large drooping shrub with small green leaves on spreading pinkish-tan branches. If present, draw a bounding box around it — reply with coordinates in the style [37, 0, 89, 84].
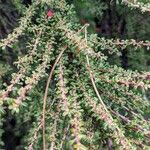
[0, 0, 150, 150]
